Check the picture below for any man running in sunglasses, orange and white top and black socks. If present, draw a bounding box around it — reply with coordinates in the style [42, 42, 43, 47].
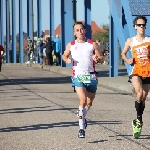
[122, 16, 150, 138]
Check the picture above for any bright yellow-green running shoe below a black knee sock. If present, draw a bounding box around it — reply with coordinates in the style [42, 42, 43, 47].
[132, 119, 143, 139]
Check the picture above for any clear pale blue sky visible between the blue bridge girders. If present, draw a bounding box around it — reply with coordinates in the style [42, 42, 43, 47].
[3, 0, 109, 33]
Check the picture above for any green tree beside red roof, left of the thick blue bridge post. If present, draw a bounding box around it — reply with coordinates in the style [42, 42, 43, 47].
[92, 24, 109, 42]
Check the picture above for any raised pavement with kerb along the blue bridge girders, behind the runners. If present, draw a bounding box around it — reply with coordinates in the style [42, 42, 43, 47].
[21, 64, 150, 98]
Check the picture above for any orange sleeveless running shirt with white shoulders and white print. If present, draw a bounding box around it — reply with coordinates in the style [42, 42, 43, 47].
[130, 37, 150, 77]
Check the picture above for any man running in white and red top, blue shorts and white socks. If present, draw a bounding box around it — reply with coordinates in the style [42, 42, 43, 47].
[62, 22, 104, 138]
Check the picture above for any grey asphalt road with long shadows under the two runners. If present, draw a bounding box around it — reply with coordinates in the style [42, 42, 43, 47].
[0, 65, 150, 150]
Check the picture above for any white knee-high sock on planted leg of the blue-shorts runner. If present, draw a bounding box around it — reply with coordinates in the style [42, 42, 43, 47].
[79, 106, 86, 130]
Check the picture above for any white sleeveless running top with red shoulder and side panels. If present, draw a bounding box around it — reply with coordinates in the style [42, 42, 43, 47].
[70, 40, 96, 79]
